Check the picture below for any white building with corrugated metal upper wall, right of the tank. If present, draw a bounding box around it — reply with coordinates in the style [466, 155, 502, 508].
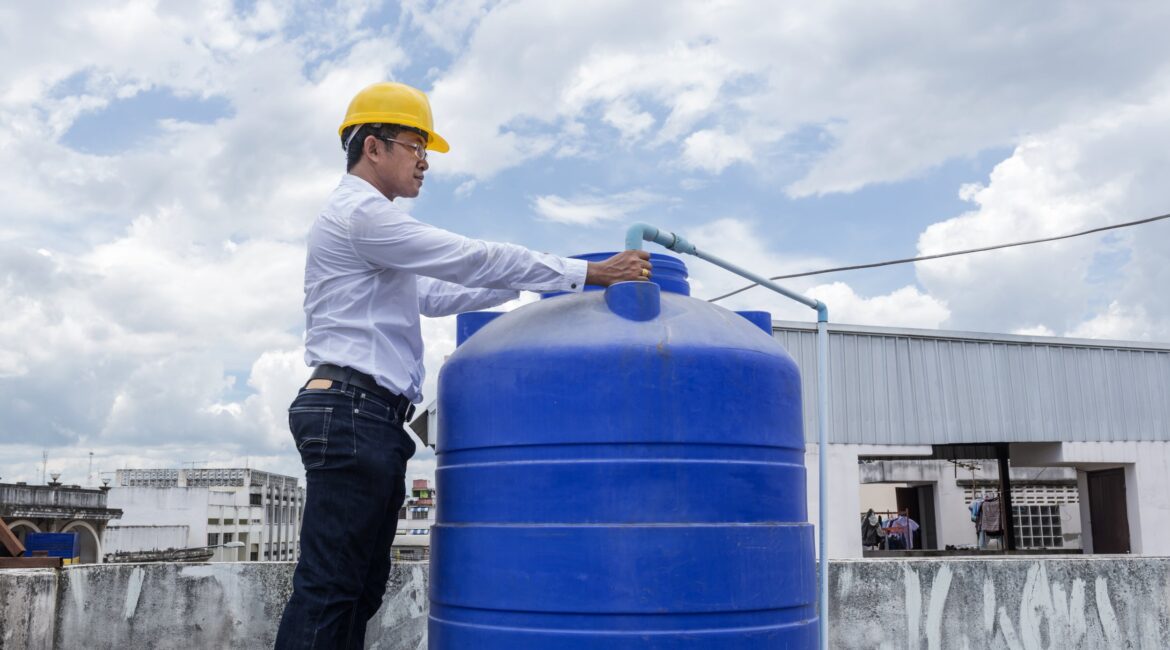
[411, 321, 1170, 559]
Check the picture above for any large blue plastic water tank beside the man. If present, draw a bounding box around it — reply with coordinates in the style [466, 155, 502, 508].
[428, 258, 817, 650]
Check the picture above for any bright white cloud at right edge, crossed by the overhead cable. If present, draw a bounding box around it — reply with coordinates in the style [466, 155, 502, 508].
[916, 90, 1170, 338]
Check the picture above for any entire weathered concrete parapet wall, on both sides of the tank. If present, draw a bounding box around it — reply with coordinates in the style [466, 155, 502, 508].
[0, 556, 1170, 650]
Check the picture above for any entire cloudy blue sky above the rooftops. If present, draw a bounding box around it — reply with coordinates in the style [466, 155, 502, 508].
[0, 0, 1170, 484]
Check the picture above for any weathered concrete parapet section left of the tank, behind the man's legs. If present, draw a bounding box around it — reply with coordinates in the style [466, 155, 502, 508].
[0, 562, 427, 650]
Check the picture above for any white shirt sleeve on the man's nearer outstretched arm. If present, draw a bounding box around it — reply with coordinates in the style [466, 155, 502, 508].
[350, 196, 589, 291]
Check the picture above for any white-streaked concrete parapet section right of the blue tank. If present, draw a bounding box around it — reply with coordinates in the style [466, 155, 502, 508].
[830, 556, 1170, 650]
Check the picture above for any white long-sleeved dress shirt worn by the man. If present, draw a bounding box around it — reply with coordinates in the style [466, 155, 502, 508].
[304, 174, 589, 402]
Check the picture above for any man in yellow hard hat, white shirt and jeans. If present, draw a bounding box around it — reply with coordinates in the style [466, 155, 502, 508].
[276, 83, 651, 649]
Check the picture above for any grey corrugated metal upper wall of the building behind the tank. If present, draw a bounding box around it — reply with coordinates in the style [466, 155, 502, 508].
[773, 321, 1170, 444]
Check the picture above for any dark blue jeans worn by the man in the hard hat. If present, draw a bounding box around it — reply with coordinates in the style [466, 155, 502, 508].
[276, 382, 414, 650]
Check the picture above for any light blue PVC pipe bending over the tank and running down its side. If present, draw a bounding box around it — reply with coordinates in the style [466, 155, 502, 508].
[626, 223, 828, 650]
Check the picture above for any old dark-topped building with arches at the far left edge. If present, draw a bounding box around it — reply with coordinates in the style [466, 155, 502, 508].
[0, 475, 122, 563]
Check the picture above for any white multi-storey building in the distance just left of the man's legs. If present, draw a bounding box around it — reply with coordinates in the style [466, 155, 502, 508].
[106, 468, 304, 561]
